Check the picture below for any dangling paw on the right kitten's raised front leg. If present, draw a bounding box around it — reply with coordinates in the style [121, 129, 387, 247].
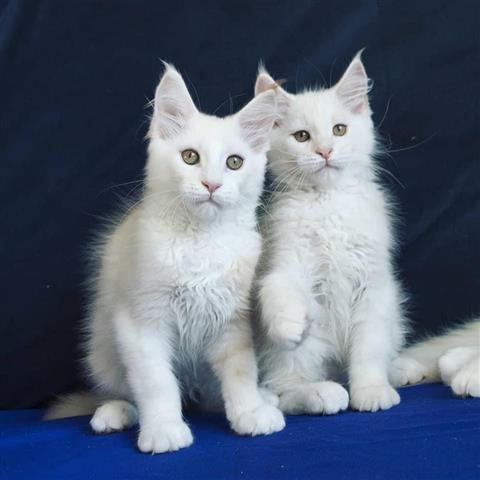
[269, 308, 307, 350]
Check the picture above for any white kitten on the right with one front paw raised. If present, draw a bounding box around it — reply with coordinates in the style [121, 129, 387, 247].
[256, 51, 404, 414]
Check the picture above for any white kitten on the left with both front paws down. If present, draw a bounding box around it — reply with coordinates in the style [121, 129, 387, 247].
[49, 65, 285, 452]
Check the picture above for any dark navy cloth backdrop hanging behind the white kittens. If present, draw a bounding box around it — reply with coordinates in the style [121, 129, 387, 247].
[0, 0, 480, 408]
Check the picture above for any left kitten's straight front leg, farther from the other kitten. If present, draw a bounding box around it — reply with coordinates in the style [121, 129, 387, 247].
[115, 311, 193, 453]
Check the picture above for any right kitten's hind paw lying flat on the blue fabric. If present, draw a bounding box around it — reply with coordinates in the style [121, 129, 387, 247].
[279, 381, 349, 415]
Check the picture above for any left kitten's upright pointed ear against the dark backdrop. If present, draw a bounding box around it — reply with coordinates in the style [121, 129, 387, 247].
[150, 63, 198, 139]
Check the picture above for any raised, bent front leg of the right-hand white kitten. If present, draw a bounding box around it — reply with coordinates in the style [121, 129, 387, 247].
[259, 270, 308, 349]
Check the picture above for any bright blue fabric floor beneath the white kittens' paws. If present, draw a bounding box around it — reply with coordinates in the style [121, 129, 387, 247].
[0, 385, 480, 480]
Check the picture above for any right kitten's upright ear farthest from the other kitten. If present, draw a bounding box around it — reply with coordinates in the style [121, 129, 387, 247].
[333, 50, 371, 113]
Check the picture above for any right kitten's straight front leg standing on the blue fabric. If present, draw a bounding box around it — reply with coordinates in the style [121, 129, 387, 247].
[349, 284, 401, 412]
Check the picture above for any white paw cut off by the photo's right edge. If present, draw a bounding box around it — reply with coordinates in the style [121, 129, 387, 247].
[438, 347, 480, 397]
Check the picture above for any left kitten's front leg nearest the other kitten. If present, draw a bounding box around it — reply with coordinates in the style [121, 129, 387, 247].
[210, 314, 285, 435]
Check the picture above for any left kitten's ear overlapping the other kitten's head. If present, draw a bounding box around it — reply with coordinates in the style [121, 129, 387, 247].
[237, 90, 278, 151]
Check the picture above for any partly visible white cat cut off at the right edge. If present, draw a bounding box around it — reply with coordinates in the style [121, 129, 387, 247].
[390, 320, 480, 397]
